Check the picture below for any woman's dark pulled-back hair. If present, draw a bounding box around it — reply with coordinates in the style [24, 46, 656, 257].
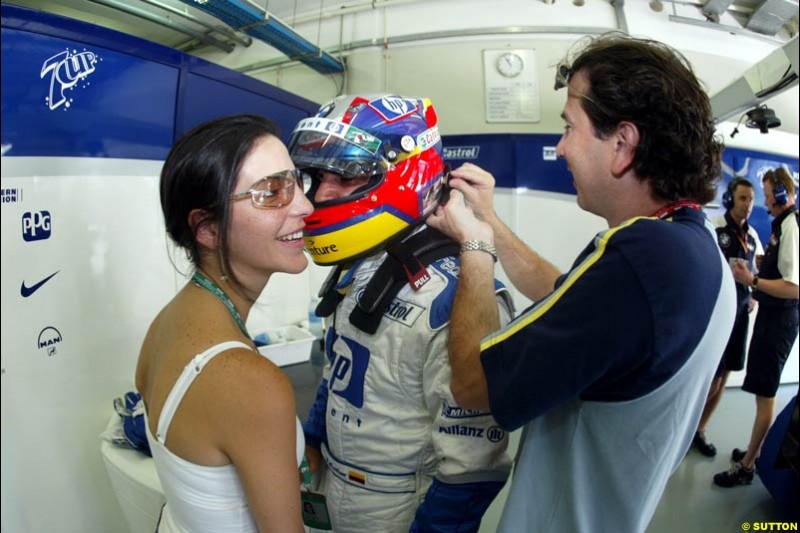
[161, 115, 278, 282]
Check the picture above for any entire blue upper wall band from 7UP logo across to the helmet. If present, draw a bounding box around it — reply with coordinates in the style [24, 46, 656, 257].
[2, 4, 318, 160]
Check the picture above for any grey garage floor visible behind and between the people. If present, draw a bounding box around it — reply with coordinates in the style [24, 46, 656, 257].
[284, 354, 798, 533]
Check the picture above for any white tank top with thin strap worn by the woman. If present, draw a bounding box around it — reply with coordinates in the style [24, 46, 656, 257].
[145, 341, 305, 533]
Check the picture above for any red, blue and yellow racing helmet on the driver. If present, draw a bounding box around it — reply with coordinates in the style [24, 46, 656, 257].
[288, 95, 446, 266]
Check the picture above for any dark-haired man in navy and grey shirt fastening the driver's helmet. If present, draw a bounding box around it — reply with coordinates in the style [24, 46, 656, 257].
[428, 34, 736, 533]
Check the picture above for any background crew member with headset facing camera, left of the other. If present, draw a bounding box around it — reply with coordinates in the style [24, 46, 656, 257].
[692, 178, 764, 457]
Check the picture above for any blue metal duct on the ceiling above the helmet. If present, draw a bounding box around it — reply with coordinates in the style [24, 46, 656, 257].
[181, 0, 344, 74]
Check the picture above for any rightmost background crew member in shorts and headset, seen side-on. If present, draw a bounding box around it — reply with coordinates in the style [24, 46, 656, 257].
[714, 168, 800, 487]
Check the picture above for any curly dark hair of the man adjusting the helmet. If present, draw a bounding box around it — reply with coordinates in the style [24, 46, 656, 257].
[562, 33, 724, 204]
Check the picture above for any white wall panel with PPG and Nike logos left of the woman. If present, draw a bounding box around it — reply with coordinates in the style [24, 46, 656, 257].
[2, 157, 176, 533]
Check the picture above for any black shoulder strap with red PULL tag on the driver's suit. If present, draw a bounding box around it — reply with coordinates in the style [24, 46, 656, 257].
[350, 227, 458, 334]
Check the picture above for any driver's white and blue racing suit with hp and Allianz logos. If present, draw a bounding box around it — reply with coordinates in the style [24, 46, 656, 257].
[303, 253, 513, 533]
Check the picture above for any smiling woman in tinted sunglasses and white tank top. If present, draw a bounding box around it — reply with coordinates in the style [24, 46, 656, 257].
[136, 115, 313, 533]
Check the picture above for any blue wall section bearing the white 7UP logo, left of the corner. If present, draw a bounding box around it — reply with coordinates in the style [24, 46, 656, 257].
[0, 28, 179, 159]
